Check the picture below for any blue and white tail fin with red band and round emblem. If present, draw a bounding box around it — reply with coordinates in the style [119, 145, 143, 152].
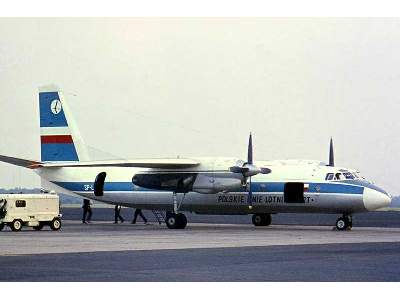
[39, 86, 89, 161]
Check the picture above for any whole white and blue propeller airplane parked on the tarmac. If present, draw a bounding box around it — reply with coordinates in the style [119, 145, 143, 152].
[0, 85, 391, 230]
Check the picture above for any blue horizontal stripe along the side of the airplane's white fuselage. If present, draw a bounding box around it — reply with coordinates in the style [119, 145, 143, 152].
[52, 181, 364, 195]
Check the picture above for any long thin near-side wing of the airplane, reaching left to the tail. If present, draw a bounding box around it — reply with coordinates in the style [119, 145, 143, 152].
[42, 158, 199, 169]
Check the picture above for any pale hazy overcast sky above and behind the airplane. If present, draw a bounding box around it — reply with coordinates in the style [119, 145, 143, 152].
[0, 18, 400, 195]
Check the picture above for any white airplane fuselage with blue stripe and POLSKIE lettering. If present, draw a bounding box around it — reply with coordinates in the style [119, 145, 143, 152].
[36, 158, 391, 214]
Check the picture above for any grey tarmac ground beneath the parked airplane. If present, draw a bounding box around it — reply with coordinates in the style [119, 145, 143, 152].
[0, 209, 400, 281]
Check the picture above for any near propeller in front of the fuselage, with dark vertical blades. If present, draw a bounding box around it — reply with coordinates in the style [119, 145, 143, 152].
[229, 133, 271, 209]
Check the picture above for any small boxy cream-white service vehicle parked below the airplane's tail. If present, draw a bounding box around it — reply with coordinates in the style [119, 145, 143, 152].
[0, 192, 61, 231]
